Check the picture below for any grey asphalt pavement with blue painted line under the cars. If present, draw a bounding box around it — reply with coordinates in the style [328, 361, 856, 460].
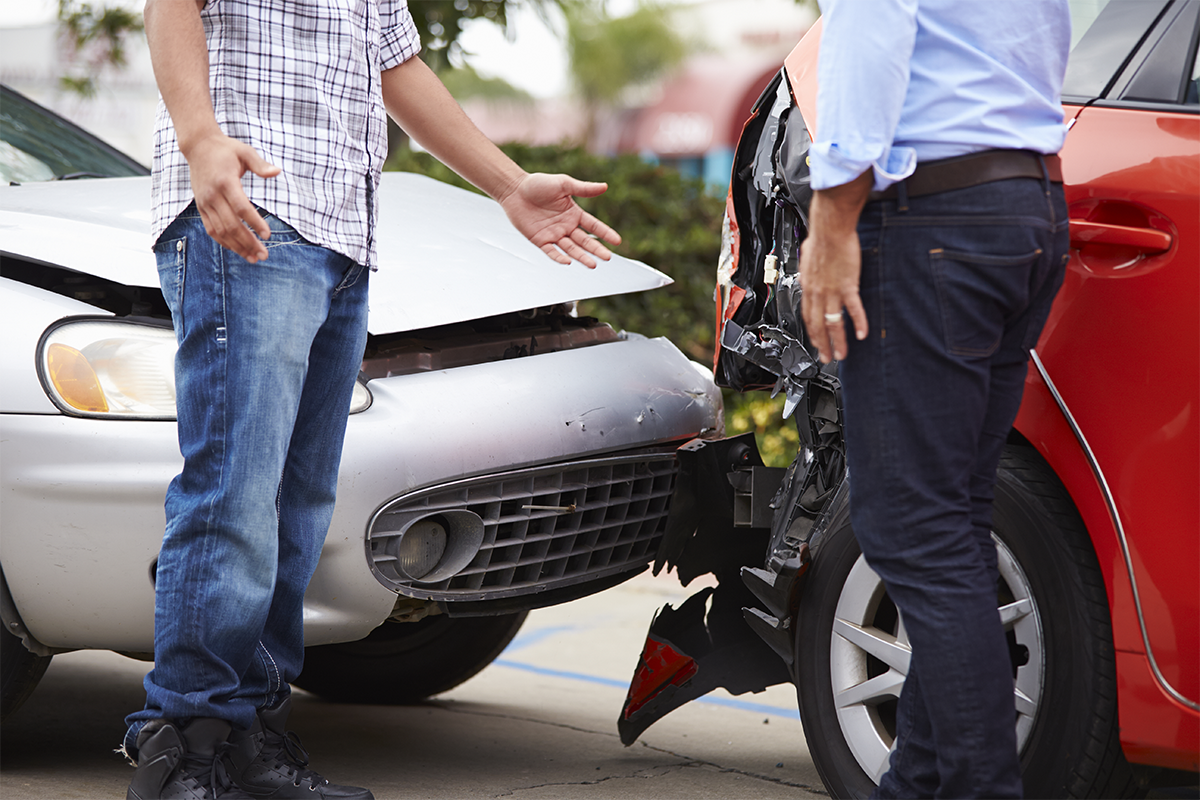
[0, 568, 1200, 800]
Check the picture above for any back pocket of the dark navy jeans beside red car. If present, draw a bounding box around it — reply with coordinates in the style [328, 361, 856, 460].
[929, 248, 1042, 357]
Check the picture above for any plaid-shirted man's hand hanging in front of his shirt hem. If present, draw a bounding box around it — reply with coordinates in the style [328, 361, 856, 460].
[184, 133, 280, 264]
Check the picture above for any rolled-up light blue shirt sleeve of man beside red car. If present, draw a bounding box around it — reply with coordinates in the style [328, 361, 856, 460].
[810, 0, 917, 191]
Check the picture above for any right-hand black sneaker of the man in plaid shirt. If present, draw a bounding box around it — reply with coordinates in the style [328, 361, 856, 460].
[222, 697, 374, 800]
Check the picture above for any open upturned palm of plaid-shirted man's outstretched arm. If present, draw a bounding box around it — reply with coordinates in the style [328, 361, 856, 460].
[498, 173, 620, 269]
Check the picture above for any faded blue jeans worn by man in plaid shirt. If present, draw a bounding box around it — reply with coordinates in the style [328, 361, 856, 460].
[125, 205, 368, 752]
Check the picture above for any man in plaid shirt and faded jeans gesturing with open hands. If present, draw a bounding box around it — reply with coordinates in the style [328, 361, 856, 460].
[124, 0, 619, 800]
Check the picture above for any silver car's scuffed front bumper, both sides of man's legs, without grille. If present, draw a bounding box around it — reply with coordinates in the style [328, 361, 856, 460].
[0, 337, 721, 651]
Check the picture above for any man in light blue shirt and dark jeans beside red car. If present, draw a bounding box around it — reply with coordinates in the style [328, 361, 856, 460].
[800, 0, 1070, 800]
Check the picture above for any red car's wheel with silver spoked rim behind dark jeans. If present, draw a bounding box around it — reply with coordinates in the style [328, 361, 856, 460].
[796, 447, 1144, 800]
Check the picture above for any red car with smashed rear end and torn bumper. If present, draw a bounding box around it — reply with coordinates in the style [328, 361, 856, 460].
[620, 0, 1200, 800]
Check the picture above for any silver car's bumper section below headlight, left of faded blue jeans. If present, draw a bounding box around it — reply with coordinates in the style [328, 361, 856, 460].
[0, 413, 171, 651]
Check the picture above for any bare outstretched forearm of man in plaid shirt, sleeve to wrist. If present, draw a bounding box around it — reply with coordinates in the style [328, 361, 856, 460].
[383, 58, 526, 200]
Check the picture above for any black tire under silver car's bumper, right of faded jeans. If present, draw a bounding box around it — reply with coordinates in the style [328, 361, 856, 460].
[295, 612, 527, 705]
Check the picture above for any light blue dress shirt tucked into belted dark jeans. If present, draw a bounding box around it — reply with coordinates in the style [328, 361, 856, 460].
[810, 0, 1070, 190]
